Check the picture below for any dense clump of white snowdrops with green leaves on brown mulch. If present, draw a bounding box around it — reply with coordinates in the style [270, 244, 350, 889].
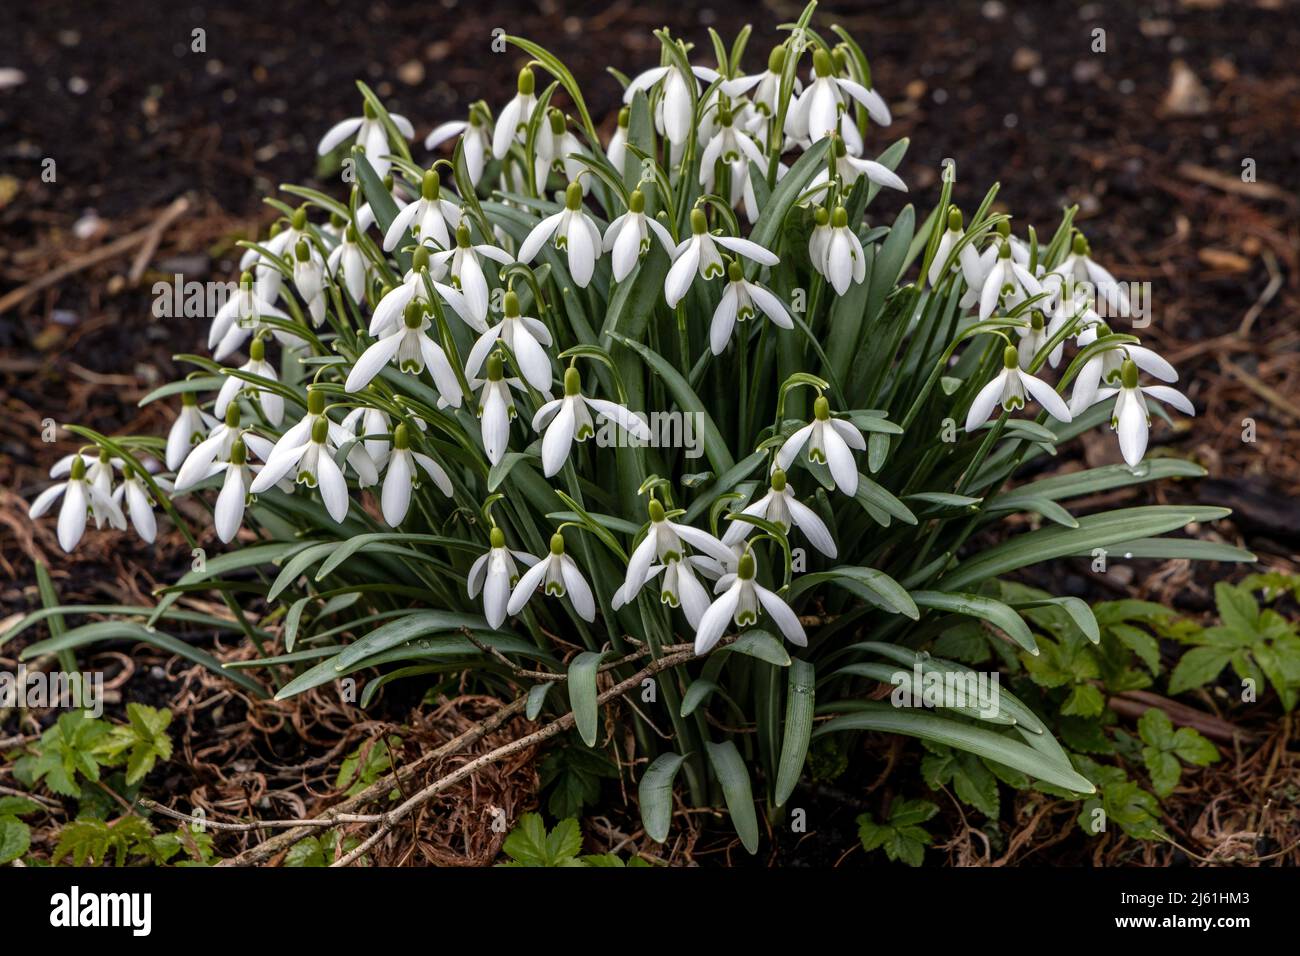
[17, 5, 1245, 852]
